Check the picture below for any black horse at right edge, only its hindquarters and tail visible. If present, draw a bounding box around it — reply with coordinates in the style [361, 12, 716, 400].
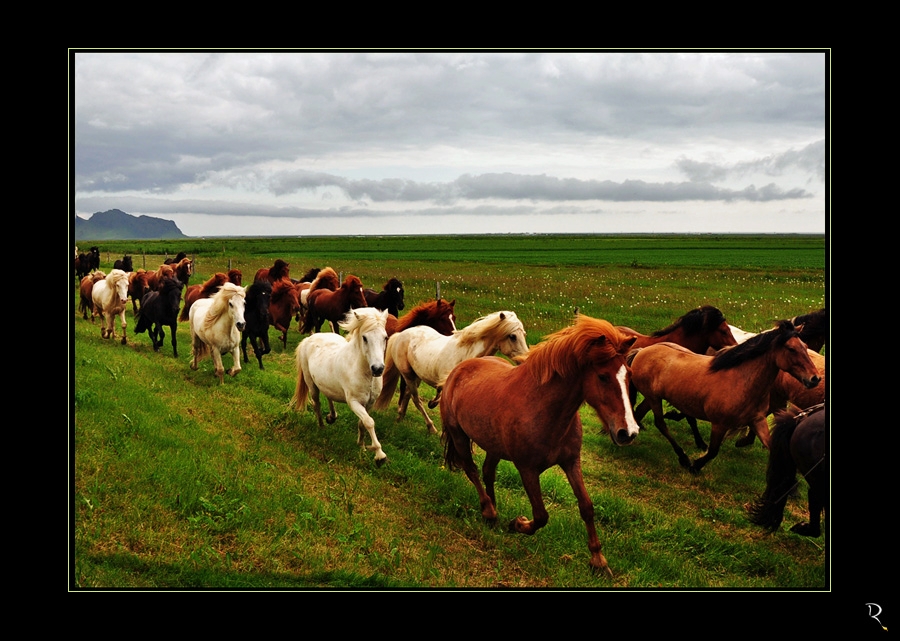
[750, 403, 828, 536]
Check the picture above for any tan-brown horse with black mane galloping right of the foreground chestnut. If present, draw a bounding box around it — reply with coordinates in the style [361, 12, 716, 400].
[629, 321, 819, 473]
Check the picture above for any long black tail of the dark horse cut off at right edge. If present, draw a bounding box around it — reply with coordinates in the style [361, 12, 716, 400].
[749, 411, 798, 532]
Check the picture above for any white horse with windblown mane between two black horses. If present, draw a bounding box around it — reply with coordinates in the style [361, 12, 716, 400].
[188, 283, 246, 384]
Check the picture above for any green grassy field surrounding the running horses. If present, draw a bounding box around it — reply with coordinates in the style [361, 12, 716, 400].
[70, 236, 829, 590]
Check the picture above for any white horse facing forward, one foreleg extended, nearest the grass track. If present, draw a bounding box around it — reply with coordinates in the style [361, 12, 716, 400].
[291, 307, 388, 465]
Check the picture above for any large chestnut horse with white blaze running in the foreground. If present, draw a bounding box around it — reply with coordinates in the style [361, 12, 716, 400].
[441, 315, 639, 576]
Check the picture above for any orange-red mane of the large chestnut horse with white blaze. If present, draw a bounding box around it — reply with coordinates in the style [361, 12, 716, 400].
[520, 314, 627, 385]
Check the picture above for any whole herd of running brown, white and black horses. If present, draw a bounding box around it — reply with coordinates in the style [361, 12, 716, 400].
[76, 248, 828, 574]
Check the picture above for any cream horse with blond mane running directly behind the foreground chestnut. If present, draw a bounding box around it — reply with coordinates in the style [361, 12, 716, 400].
[375, 311, 528, 434]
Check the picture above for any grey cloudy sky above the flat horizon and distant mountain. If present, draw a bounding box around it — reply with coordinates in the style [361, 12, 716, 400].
[70, 51, 830, 236]
